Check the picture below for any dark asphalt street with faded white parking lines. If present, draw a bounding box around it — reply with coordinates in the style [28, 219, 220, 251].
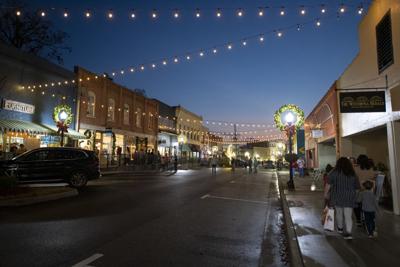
[0, 169, 281, 266]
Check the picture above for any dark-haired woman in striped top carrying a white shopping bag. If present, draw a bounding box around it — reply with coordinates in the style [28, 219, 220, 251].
[325, 157, 360, 239]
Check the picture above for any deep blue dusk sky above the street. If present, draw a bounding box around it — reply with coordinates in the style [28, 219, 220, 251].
[26, 0, 368, 123]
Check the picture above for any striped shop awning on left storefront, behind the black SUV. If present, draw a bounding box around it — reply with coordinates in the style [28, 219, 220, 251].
[0, 120, 53, 134]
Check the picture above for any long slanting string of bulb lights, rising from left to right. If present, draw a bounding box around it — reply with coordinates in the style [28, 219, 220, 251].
[21, 9, 366, 90]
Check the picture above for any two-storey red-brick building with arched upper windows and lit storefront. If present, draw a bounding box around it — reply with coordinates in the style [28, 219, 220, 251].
[75, 67, 158, 162]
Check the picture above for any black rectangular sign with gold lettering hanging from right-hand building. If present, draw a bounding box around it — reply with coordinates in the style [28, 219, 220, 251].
[339, 91, 386, 113]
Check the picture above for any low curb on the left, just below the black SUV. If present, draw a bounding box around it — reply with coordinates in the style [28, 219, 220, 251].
[0, 189, 78, 207]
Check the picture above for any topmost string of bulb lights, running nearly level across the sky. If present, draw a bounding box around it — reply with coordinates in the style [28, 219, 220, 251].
[7, 1, 368, 21]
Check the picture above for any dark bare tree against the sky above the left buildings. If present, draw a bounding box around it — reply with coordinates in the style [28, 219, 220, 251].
[0, 0, 71, 64]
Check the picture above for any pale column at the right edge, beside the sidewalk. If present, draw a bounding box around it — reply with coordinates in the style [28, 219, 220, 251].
[387, 121, 400, 215]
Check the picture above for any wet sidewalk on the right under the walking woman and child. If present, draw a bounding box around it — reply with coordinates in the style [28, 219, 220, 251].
[279, 172, 400, 267]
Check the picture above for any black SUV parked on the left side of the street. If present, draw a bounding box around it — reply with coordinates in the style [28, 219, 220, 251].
[0, 148, 100, 188]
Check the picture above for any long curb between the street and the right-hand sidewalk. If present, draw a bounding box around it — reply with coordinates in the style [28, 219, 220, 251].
[276, 172, 305, 267]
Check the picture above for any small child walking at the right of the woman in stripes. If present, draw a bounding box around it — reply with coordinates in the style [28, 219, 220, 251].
[360, 181, 378, 238]
